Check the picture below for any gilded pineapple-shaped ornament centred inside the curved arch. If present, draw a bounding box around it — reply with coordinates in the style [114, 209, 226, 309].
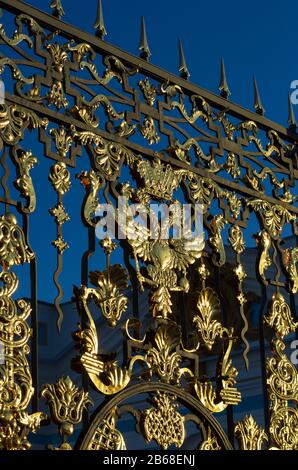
[143, 392, 185, 450]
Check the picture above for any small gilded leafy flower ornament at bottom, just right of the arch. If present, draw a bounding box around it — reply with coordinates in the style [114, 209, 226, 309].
[235, 415, 268, 450]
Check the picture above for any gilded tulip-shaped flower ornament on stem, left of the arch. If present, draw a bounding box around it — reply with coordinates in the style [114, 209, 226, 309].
[40, 377, 92, 450]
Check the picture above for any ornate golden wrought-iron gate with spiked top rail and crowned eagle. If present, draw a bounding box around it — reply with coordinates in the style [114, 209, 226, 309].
[0, 0, 298, 450]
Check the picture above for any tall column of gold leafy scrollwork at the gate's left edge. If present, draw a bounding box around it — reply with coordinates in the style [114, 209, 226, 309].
[0, 214, 46, 450]
